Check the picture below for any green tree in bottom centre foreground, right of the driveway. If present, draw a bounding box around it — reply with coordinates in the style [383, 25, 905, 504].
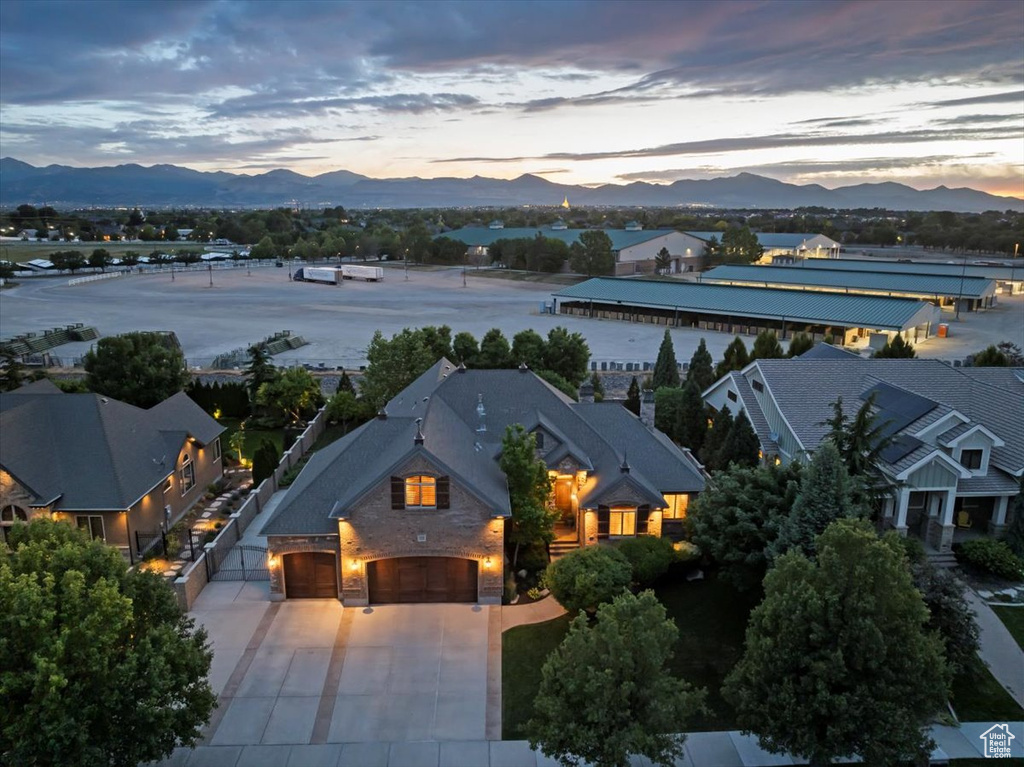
[526, 591, 705, 767]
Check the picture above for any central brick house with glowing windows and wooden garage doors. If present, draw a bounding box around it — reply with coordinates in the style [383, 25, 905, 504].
[262, 358, 705, 605]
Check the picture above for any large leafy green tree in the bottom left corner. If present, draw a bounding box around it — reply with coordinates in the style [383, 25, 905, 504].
[0, 518, 216, 767]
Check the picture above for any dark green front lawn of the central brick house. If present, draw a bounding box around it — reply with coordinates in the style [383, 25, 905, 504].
[502, 576, 760, 739]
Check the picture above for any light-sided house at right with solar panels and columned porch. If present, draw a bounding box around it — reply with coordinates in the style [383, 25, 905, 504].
[703, 350, 1024, 551]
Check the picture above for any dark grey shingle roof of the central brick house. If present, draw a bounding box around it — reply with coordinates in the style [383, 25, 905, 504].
[262, 359, 703, 536]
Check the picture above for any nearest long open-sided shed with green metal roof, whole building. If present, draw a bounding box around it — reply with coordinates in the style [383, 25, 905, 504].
[554, 278, 941, 345]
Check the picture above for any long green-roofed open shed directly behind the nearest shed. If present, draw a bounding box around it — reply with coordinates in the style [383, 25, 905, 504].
[700, 261, 995, 311]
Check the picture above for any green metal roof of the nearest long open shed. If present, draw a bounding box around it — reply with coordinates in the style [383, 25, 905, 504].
[554, 278, 939, 330]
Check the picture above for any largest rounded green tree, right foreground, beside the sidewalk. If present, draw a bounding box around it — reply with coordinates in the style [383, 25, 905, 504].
[724, 519, 950, 765]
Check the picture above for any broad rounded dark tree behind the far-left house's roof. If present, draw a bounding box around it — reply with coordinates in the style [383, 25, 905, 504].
[83, 333, 188, 408]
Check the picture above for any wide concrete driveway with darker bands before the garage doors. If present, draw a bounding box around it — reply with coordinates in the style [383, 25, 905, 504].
[193, 583, 501, 747]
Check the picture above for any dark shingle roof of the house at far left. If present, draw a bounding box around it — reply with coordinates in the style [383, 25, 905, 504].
[0, 389, 224, 510]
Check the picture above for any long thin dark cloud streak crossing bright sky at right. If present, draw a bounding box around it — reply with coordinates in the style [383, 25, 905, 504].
[432, 127, 1020, 163]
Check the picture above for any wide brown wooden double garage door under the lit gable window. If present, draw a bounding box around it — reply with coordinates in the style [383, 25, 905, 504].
[367, 557, 476, 604]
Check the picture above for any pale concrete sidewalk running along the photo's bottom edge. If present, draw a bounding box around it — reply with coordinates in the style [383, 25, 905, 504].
[151, 722, 1024, 767]
